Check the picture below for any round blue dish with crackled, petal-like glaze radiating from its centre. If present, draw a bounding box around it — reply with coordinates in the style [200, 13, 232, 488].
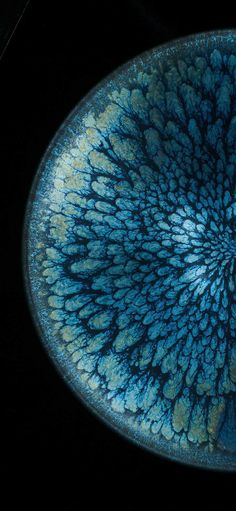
[26, 31, 236, 470]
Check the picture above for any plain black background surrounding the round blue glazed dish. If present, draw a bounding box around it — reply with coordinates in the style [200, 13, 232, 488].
[0, 0, 236, 500]
